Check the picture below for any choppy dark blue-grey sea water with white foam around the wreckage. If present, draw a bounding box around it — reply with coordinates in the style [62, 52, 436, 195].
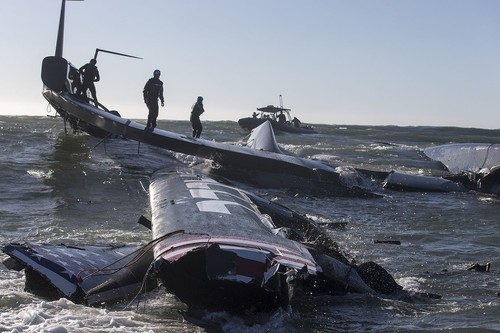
[0, 116, 500, 333]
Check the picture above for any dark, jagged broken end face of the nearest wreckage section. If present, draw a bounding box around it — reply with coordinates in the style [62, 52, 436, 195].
[155, 244, 294, 313]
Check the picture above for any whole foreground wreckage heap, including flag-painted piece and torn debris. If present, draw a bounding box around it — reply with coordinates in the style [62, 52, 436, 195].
[3, 171, 400, 313]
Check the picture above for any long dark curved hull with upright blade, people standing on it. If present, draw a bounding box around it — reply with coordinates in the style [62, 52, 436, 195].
[42, 1, 377, 197]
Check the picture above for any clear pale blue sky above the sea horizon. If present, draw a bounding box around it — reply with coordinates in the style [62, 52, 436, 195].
[0, 0, 500, 128]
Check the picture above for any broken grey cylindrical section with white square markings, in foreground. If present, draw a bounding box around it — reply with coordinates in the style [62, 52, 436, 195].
[150, 173, 317, 312]
